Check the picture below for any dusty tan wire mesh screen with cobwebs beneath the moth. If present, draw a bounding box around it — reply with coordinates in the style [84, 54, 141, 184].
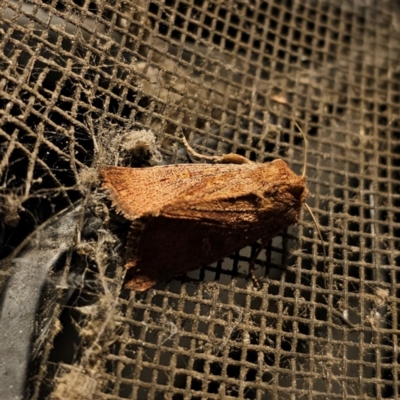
[0, 0, 400, 399]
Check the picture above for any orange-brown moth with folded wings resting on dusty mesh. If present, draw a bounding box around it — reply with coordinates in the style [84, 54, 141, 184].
[100, 139, 308, 291]
